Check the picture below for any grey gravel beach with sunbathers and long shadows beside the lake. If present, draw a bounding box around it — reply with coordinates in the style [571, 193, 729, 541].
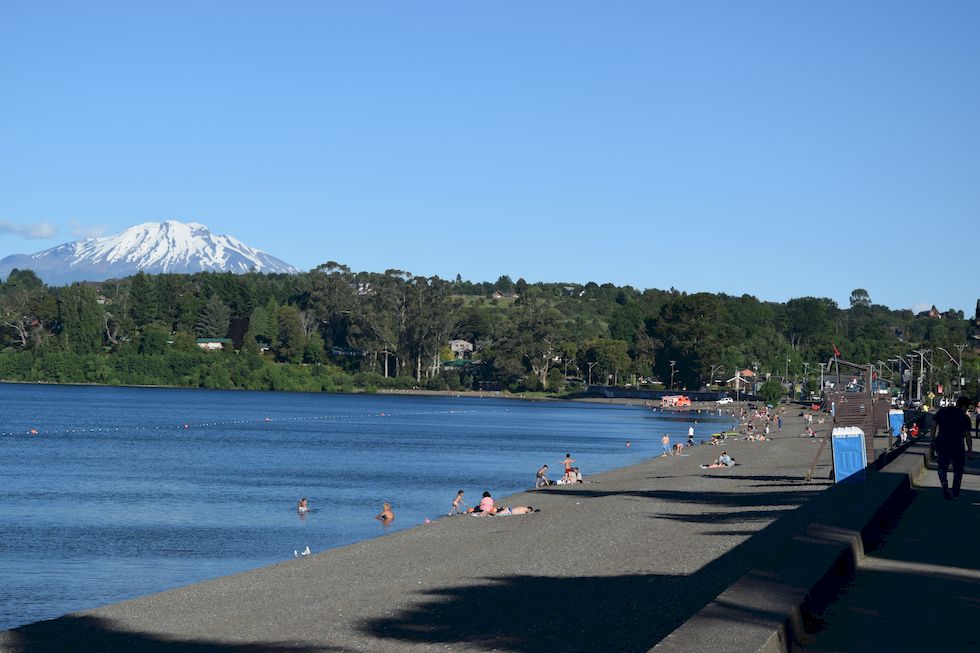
[0, 407, 844, 653]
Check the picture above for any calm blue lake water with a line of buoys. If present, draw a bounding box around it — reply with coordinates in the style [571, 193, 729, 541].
[0, 384, 728, 630]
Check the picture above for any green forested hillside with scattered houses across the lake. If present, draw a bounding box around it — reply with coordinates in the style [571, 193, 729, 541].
[0, 262, 980, 395]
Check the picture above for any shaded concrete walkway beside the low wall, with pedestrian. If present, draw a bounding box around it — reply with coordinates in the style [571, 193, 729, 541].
[800, 440, 980, 653]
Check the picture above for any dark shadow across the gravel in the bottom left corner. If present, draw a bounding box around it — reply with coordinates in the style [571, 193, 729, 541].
[0, 616, 347, 653]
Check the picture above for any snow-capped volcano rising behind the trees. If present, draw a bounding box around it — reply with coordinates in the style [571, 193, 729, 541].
[0, 220, 299, 285]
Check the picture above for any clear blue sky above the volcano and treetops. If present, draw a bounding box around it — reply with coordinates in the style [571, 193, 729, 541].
[0, 0, 980, 313]
